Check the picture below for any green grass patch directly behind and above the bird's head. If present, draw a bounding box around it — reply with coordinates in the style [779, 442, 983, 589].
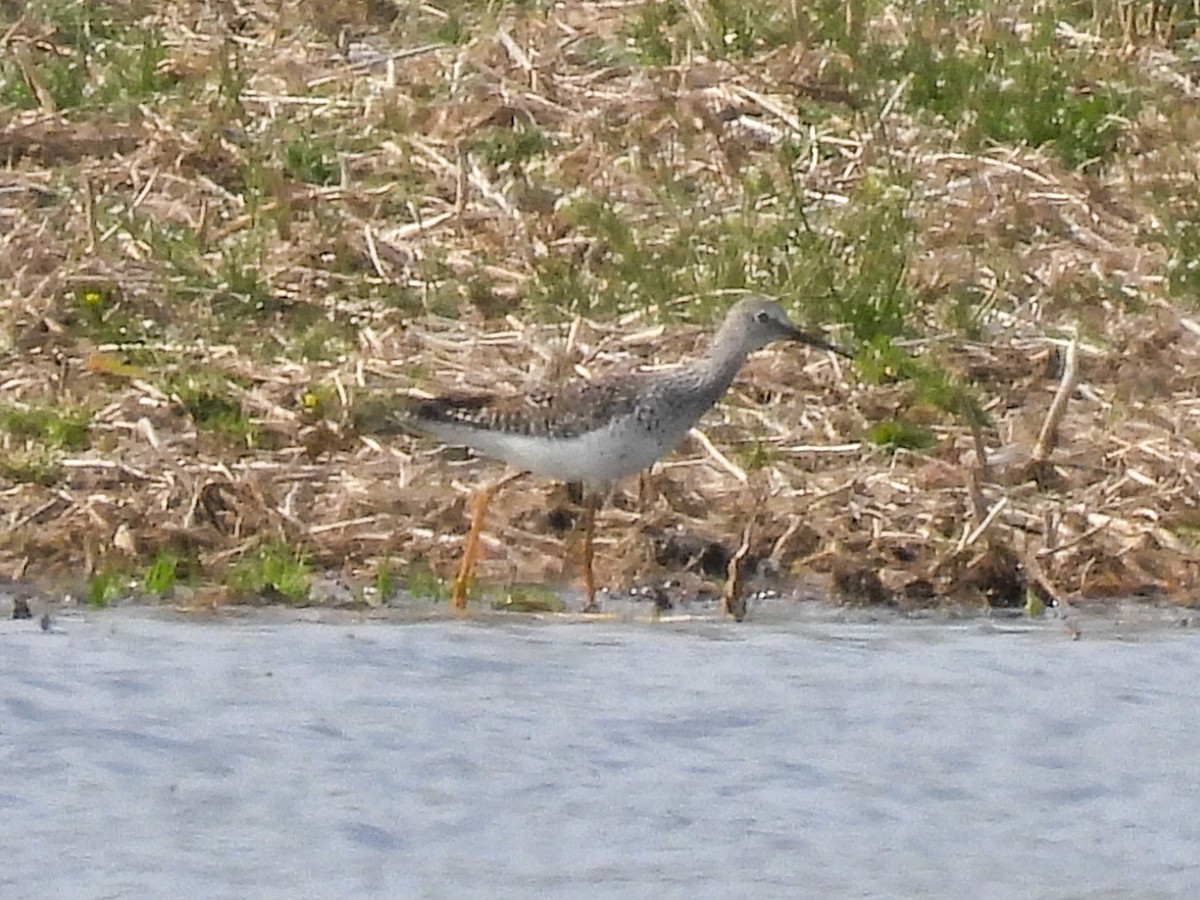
[528, 168, 920, 341]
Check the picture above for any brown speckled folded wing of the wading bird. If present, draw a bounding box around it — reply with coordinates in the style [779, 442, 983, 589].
[409, 374, 648, 438]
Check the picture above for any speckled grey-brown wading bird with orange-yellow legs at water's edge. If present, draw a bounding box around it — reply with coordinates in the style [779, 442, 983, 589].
[404, 296, 850, 610]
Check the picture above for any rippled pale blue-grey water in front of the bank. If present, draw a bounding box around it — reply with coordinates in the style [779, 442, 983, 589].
[0, 611, 1200, 899]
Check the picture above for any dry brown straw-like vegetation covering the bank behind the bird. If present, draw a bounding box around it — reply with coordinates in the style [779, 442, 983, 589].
[0, 2, 1200, 607]
